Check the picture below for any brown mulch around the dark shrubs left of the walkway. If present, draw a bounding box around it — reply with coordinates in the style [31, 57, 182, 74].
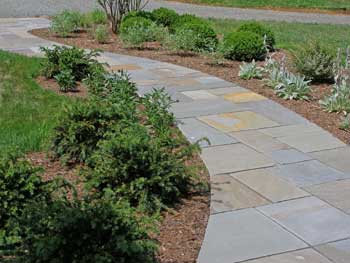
[27, 153, 210, 263]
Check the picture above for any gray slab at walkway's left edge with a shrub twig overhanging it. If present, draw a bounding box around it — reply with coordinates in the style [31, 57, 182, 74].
[178, 118, 237, 147]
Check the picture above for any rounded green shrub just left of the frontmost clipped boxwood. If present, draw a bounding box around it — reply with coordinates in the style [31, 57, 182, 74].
[175, 22, 218, 51]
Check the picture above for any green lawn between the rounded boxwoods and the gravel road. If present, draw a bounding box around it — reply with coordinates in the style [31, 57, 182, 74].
[209, 19, 350, 49]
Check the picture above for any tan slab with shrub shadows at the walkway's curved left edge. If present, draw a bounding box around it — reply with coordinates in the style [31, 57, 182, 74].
[211, 175, 270, 214]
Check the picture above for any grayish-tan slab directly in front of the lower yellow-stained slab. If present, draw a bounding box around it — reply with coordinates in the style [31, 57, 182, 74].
[230, 130, 289, 153]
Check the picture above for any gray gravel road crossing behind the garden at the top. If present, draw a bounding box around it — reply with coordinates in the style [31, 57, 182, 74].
[0, 0, 350, 25]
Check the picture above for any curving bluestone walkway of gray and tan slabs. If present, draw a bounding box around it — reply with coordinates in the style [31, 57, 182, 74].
[0, 19, 350, 263]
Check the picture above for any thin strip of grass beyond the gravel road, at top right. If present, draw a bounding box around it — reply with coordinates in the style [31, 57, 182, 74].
[176, 0, 350, 10]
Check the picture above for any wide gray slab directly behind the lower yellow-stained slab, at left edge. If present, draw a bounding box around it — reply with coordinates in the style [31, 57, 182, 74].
[171, 99, 244, 118]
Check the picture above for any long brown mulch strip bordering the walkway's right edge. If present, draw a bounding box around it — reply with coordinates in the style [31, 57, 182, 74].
[31, 29, 350, 143]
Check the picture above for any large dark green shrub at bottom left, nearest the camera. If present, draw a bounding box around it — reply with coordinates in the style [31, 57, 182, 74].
[14, 198, 157, 263]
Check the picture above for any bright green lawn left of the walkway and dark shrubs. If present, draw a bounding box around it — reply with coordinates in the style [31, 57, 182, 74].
[0, 50, 71, 152]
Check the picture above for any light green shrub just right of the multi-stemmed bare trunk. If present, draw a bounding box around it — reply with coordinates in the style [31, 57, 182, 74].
[120, 17, 167, 48]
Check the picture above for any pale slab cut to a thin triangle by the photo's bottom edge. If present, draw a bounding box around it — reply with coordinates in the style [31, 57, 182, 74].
[246, 248, 332, 263]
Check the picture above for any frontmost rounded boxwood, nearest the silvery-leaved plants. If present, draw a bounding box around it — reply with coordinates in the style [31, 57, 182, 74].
[221, 32, 266, 61]
